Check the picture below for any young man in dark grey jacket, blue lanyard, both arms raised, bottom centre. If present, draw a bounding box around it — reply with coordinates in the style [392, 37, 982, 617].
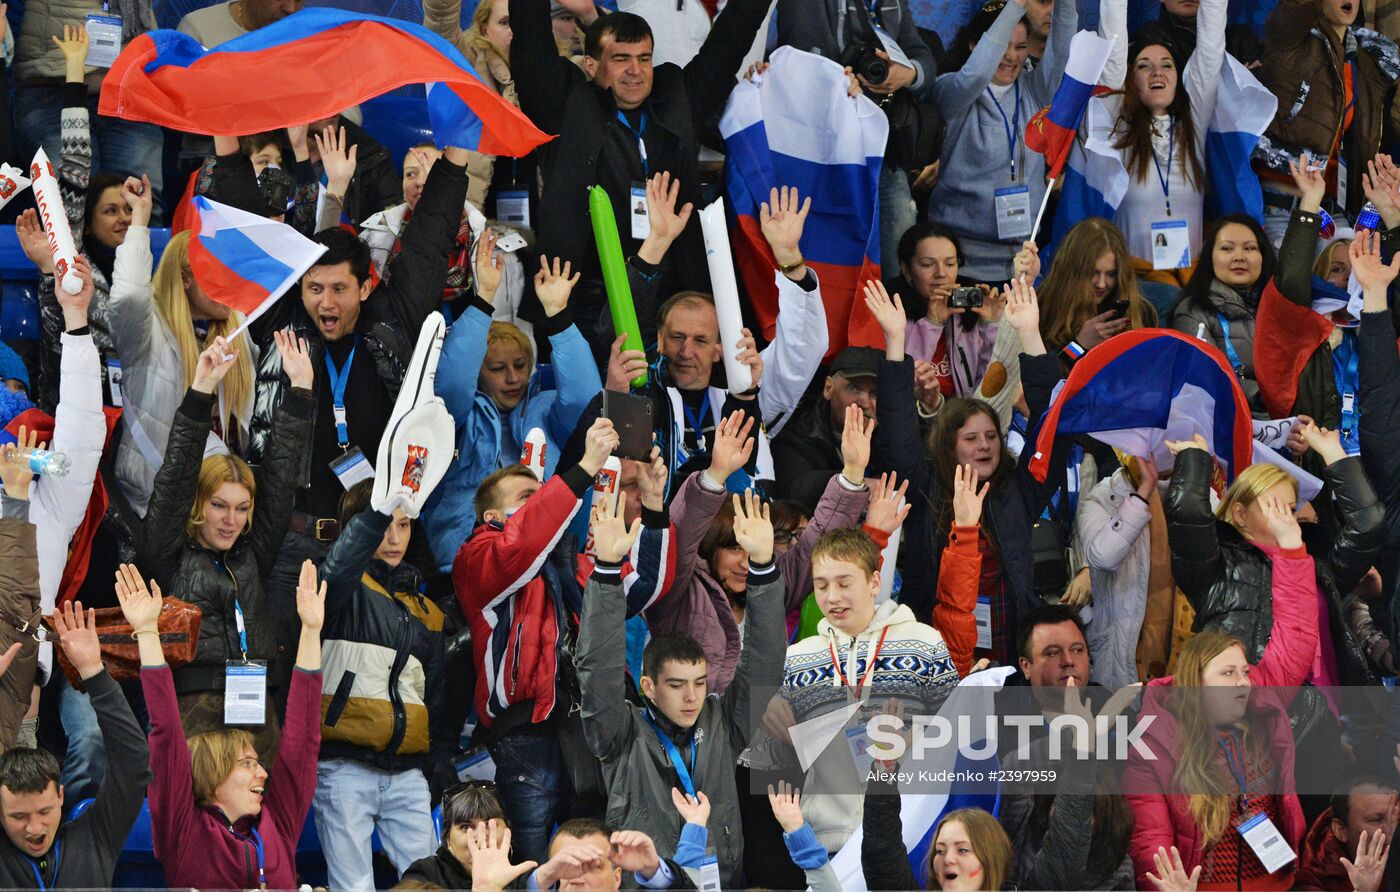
[575, 487, 787, 889]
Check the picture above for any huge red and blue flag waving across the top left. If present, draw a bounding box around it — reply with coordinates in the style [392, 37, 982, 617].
[98, 7, 550, 157]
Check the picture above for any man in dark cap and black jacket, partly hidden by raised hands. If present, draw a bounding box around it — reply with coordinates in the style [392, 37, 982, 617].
[773, 347, 881, 517]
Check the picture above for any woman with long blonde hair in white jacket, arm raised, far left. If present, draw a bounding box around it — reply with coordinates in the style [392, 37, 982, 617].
[111, 176, 253, 515]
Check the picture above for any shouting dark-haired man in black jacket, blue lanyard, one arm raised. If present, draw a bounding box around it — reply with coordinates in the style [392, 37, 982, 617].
[248, 147, 466, 710]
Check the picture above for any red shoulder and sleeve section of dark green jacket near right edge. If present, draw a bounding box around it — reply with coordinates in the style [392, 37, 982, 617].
[1254, 280, 1331, 419]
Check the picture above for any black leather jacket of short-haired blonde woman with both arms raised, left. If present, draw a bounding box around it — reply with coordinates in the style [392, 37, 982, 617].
[139, 388, 312, 693]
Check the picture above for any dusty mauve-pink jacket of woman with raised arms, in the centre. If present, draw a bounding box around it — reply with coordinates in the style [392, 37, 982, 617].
[647, 473, 869, 693]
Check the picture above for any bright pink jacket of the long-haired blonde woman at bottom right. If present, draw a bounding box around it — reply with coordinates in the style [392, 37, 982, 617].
[1123, 548, 1317, 889]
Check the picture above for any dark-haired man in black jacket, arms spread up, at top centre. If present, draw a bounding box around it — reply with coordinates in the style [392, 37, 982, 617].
[510, 0, 771, 336]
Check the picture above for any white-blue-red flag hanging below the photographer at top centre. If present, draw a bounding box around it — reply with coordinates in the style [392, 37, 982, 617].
[720, 46, 889, 357]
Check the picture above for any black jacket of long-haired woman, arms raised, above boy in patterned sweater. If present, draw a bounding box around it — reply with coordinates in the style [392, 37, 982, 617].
[871, 353, 1071, 629]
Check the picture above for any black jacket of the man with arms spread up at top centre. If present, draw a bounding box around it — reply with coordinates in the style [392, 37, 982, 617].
[506, 0, 770, 292]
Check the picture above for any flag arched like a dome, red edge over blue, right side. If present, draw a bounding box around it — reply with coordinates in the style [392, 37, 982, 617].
[1030, 328, 1254, 482]
